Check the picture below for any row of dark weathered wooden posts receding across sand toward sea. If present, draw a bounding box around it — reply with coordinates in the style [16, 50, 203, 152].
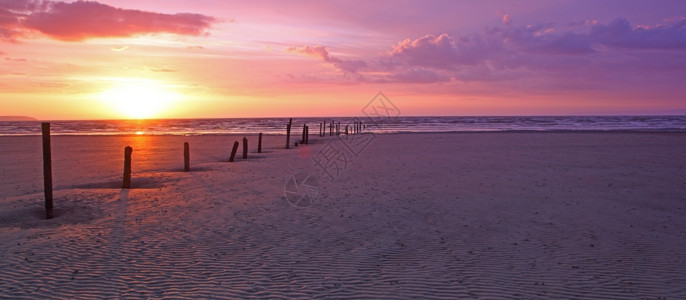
[41, 118, 364, 219]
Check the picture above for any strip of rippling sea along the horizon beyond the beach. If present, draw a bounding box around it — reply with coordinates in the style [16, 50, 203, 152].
[0, 116, 686, 136]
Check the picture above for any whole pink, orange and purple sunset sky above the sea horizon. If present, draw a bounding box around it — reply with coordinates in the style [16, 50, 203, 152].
[0, 0, 686, 119]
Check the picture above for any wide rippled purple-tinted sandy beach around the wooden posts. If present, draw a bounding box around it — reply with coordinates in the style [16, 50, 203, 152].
[0, 132, 686, 299]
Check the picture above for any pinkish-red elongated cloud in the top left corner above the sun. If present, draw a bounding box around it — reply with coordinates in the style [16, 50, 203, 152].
[0, 0, 218, 41]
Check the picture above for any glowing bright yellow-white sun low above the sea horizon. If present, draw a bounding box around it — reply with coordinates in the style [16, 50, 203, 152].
[97, 79, 183, 119]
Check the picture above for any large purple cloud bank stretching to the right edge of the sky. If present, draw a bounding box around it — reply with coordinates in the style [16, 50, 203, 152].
[376, 17, 686, 87]
